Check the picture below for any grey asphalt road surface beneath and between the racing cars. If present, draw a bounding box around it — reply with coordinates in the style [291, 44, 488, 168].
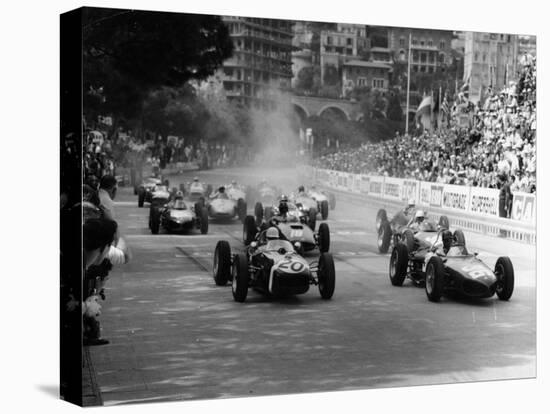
[91, 169, 536, 405]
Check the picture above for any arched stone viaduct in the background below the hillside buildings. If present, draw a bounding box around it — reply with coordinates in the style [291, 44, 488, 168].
[291, 95, 416, 122]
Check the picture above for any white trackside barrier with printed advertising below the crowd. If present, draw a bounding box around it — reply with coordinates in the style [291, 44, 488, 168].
[302, 167, 536, 244]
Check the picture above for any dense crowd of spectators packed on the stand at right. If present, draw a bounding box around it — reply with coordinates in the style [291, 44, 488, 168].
[314, 57, 536, 193]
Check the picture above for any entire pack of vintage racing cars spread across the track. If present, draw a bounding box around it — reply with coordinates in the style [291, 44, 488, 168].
[134, 171, 514, 302]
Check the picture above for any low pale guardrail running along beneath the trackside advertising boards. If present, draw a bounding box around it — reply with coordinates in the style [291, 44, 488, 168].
[320, 185, 537, 244]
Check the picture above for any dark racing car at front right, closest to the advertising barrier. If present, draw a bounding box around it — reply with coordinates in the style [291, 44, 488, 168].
[389, 229, 514, 302]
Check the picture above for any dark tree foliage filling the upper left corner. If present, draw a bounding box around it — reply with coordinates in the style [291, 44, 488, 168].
[83, 8, 233, 118]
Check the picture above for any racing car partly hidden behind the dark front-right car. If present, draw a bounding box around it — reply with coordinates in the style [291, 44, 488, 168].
[376, 209, 449, 253]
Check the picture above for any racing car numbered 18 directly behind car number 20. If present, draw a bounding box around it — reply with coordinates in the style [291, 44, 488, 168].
[243, 209, 330, 254]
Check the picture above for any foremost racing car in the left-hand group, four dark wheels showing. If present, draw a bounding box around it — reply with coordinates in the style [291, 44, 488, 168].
[149, 191, 208, 234]
